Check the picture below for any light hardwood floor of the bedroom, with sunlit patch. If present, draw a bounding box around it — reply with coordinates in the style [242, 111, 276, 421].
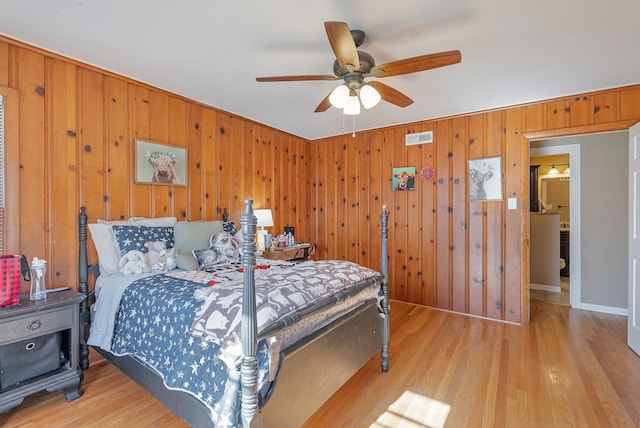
[0, 301, 640, 428]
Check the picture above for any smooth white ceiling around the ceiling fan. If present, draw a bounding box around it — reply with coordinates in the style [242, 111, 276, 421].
[0, 0, 640, 139]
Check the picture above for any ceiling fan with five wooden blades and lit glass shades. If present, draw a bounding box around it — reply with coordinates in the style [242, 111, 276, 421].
[256, 21, 462, 115]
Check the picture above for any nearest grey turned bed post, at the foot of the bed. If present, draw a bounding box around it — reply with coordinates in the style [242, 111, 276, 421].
[240, 198, 258, 428]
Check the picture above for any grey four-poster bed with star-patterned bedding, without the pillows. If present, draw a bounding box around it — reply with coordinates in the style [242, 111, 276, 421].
[78, 199, 390, 427]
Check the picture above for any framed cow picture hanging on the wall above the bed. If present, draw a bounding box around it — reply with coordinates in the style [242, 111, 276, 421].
[136, 139, 187, 186]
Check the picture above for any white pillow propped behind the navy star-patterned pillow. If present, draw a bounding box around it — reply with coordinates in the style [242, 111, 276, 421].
[88, 217, 177, 276]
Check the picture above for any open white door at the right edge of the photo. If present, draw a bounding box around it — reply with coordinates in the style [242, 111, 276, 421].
[627, 123, 640, 355]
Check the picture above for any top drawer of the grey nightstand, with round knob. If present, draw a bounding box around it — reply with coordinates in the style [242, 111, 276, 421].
[0, 307, 74, 343]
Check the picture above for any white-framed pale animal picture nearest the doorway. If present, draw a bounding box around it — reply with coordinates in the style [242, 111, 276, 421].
[469, 156, 502, 201]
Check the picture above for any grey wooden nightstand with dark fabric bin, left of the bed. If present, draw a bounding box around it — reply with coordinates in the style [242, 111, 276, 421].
[0, 290, 84, 413]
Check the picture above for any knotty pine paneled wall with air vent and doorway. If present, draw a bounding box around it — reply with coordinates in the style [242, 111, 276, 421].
[307, 86, 640, 323]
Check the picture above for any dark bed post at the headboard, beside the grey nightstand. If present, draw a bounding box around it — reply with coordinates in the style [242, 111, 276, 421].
[78, 207, 90, 370]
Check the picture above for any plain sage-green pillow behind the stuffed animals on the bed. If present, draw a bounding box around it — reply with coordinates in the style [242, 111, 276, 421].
[173, 220, 223, 270]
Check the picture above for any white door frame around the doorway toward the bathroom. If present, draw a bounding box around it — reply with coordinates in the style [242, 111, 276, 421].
[529, 144, 582, 309]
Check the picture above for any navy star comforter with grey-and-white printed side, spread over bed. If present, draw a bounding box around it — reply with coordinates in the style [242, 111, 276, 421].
[104, 261, 379, 427]
